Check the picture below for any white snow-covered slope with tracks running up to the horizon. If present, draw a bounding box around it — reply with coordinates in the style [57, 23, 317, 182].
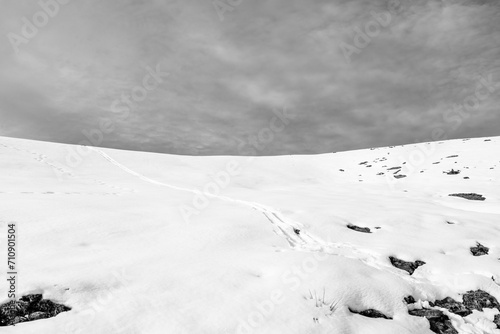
[0, 137, 500, 334]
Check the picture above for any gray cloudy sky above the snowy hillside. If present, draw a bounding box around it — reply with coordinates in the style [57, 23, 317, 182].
[0, 0, 500, 155]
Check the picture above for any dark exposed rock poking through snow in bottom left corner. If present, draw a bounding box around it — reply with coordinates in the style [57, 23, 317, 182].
[0, 294, 71, 326]
